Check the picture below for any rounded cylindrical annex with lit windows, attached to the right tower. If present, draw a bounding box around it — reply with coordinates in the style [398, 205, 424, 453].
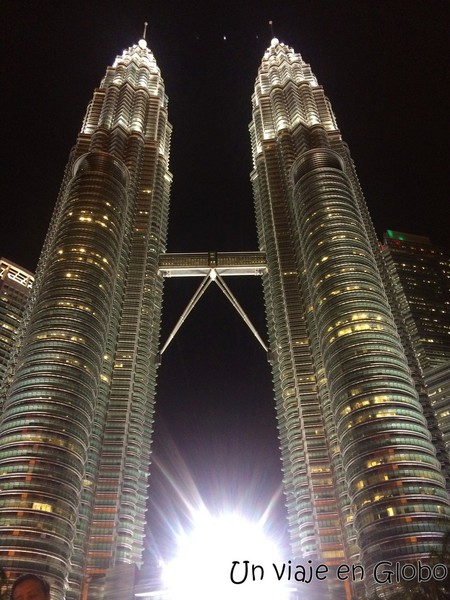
[292, 148, 450, 590]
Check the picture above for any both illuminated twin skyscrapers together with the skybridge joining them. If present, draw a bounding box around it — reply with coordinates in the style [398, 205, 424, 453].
[0, 39, 450, 600]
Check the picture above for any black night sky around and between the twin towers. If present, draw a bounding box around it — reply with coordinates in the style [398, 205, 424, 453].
[0, 0, 450, 564]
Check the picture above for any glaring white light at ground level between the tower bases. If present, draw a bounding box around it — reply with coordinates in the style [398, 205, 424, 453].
[164, 512, 289, 600]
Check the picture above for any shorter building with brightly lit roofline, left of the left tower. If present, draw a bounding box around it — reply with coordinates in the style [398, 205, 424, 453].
[0, 258, 34, 386]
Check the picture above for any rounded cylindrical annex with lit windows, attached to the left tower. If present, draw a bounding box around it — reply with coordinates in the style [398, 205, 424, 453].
[0, 153, 128, 584]
